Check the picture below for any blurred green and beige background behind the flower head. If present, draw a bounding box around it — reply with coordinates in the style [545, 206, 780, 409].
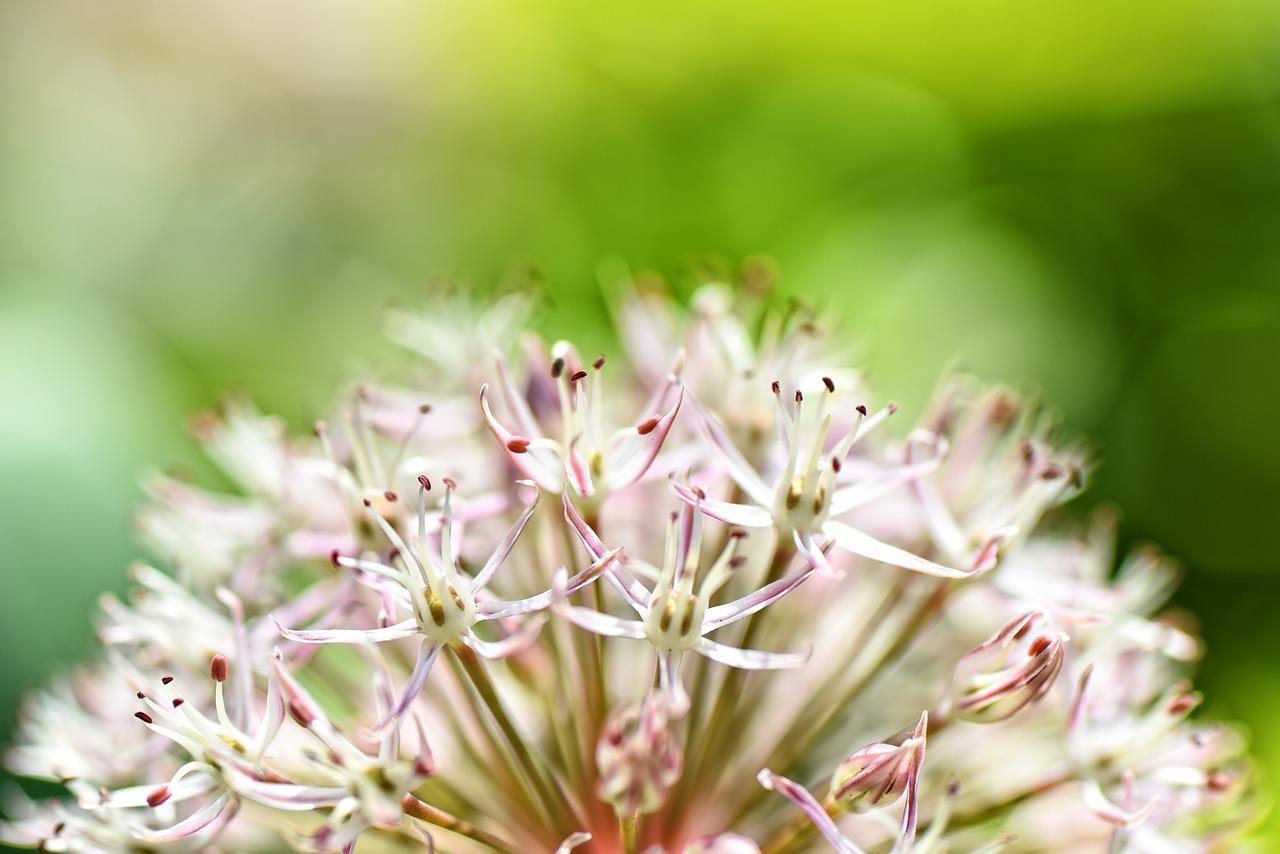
[0, 0, 1280, 850]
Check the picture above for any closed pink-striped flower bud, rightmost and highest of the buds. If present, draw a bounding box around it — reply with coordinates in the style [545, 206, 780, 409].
[951, 611, 1068, 723]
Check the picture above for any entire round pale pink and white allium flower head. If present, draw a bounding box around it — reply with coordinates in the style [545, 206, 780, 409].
[0, 277, 1252, 854]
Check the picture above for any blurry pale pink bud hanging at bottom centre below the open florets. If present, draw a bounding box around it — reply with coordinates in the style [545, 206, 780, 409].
[595, 695, 685, 816]
